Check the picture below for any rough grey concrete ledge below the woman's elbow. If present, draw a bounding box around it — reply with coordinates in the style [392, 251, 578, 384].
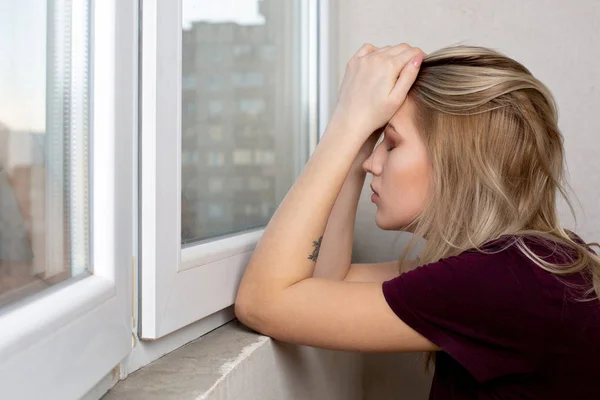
[103, 320, 363, 400]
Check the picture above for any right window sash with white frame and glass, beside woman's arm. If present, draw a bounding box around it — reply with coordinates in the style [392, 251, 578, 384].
[140, 0, 324, 339]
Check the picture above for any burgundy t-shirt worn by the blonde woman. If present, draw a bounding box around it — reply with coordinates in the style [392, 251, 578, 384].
[383, 236, 600, 400]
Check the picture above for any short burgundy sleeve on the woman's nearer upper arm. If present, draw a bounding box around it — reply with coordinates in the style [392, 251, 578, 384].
[382, 250, 545, 382]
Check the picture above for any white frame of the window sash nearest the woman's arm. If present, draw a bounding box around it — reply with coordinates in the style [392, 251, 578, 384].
[138, 0, 337, 340]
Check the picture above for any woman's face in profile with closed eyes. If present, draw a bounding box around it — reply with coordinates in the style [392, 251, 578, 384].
[363, 99, 431, 230]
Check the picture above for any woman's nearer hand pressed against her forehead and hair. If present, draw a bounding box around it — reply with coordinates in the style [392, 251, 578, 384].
[332, 43, 424, 140]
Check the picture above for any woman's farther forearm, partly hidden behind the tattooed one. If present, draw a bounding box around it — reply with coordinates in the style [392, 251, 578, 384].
[313, 161, 366, 280]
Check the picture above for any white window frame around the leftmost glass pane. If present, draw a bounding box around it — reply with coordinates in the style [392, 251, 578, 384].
[0, 0, 138, 399]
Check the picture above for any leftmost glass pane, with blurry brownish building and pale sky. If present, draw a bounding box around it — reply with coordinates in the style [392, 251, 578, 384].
[0, 0, 89, 307]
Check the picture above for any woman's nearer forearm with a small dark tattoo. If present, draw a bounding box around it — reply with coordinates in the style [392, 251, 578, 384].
[238, 115, 363, 300]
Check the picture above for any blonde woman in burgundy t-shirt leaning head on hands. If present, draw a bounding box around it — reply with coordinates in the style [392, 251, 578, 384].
[236, 44, 600, 399]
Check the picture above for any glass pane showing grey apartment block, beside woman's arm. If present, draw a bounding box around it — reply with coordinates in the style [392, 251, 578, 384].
[181, 0, 308, 245]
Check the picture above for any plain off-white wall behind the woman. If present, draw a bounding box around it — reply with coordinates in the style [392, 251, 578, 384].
[336, 0, 600, 400]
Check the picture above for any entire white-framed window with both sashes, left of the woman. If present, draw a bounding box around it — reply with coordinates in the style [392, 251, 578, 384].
[0, 0, 328, 399]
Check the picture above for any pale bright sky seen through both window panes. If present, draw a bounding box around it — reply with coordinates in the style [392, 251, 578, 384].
[0, 0, 264, 132]
